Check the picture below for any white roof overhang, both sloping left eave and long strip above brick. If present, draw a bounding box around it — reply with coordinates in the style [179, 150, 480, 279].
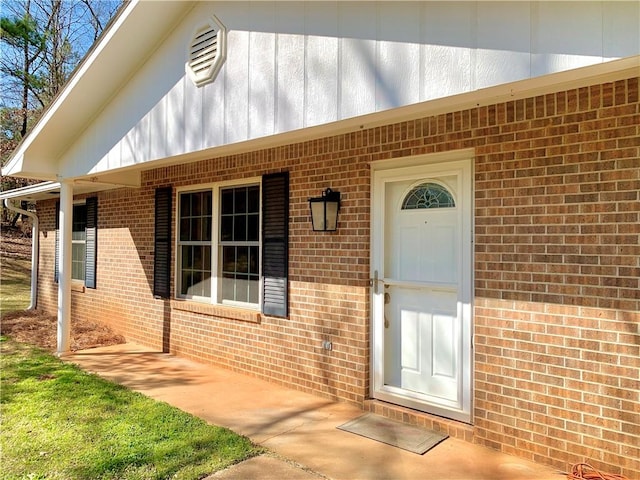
[2, 0, 640, 186]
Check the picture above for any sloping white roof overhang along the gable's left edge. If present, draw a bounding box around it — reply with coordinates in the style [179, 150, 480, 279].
[2, 0, 194, 180]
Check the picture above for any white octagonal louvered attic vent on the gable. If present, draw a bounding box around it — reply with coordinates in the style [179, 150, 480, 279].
[186, 16, 227, 86]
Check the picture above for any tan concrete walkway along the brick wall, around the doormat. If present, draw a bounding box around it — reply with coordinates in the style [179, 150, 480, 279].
[66, 344, 566, 480]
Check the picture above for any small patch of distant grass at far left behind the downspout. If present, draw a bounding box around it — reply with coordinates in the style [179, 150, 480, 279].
[0, 256, 31, 314]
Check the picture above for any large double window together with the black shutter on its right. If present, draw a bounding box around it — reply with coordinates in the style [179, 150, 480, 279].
[176, 173, 289, 316]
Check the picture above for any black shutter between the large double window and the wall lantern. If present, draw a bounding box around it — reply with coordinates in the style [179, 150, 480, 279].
[262, 172, 289, 317]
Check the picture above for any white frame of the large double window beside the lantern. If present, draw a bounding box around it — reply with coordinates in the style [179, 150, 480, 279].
[174, 177, 263, 311]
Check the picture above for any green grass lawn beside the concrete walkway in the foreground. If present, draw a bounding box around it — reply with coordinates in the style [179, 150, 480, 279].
[0, 337, 260, 479]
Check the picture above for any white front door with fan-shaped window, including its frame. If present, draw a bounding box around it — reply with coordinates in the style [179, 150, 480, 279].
[371, 157, 472, 422]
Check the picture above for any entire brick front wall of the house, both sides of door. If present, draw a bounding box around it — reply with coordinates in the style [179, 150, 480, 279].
[39, 78, 640, 477]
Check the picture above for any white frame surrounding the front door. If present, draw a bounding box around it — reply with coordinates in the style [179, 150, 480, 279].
[370, 149, 475, 423]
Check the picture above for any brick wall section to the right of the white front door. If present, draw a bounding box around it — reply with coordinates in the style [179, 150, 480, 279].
[474, 78, 640, 477]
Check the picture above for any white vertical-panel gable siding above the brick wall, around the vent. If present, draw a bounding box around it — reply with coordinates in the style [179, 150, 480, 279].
[60, 1, 640, 177]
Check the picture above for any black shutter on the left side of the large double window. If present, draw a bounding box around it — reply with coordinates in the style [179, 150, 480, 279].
[153, 187, 172, 298]
